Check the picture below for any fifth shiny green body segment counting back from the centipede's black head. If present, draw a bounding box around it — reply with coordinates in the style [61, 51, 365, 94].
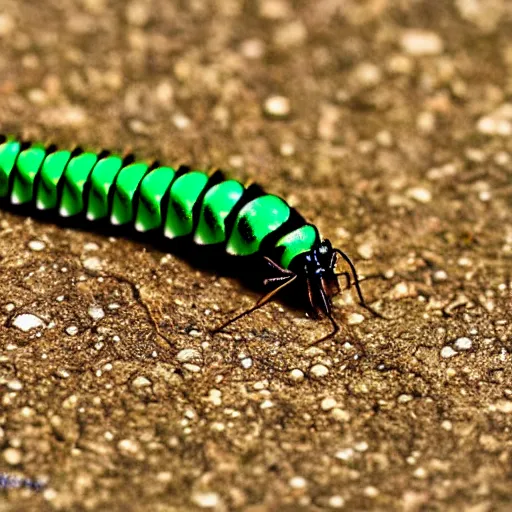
[135, 167, 176, 231]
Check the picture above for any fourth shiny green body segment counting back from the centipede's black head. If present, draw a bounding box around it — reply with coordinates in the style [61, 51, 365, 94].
[164, 171, 208, 238]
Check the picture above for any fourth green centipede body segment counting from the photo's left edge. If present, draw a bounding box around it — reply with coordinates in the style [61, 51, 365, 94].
[59, 153, 98, 217]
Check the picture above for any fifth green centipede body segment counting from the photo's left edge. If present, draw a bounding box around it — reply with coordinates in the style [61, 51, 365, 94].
[87, 155, 123, 220]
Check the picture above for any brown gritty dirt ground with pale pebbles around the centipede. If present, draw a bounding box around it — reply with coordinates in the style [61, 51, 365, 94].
[0, 0, 512, 512]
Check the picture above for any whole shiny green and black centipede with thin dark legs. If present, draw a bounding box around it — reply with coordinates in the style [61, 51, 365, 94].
[0, 136, 372, 341]
